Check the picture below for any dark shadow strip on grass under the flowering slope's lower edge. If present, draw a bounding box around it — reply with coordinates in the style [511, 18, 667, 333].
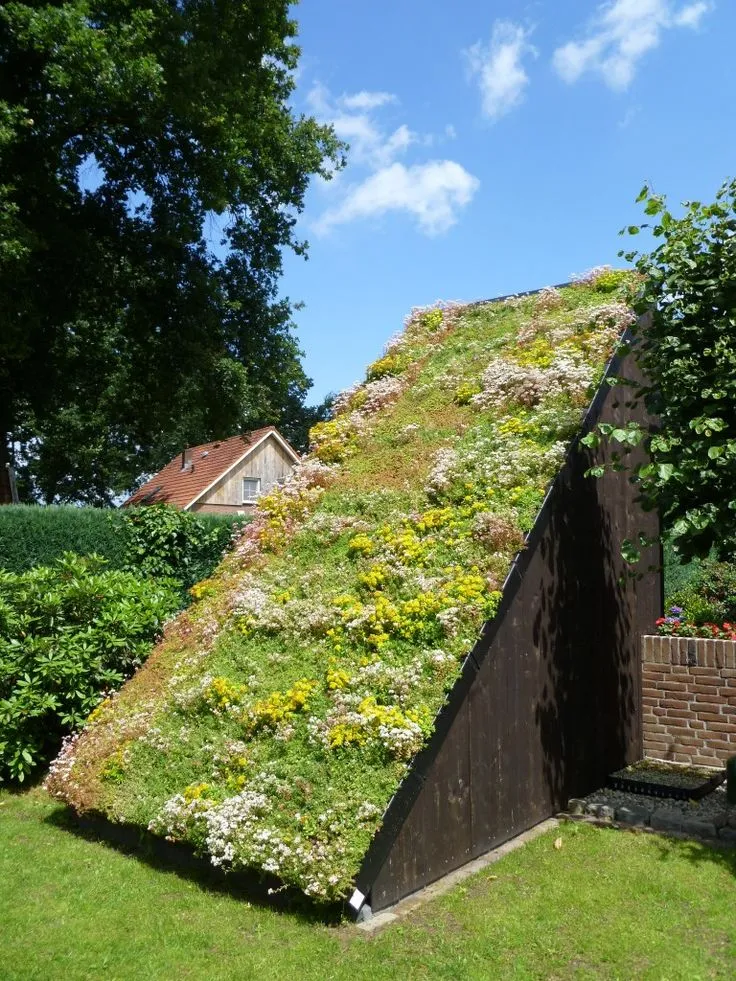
[43, 806, 345, 926]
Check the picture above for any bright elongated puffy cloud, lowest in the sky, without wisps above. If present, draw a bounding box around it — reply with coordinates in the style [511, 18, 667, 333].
[315, 160, 480, 235]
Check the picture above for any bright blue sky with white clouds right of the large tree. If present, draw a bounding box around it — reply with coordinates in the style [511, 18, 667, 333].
[282, 0, 736, 401]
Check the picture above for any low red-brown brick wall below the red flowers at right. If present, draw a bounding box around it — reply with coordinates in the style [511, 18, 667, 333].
[642, 637, 736, 766]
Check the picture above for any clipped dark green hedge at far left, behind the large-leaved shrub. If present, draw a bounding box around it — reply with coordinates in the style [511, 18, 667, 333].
[0, 504, 125, 572]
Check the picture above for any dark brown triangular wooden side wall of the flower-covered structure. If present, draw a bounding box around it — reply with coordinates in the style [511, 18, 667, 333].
[357, 350, 662, 911]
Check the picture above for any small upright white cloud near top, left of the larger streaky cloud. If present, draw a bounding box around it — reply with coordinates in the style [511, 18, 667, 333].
[464, 20, 537, 122]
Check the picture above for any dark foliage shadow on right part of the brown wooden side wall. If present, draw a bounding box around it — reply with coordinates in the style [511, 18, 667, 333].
[533, 390, 659, 809]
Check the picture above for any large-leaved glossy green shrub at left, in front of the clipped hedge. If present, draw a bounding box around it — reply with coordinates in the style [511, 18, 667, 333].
[0, 553, 179, 781]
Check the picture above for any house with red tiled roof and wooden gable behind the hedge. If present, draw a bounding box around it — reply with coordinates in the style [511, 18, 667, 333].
[123, 426, 299, 514]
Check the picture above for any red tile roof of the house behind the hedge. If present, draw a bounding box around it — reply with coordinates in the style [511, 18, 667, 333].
[123, 426, 297, 509]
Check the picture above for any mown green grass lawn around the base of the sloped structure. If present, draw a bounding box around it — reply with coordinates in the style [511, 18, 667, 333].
[0, 789, 736, 981]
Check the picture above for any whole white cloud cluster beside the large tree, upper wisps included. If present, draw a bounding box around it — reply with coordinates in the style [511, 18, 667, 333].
[307, 83, 480, 235]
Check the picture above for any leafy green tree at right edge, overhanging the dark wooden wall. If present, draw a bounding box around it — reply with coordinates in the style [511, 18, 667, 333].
[592, 181, 736, 559]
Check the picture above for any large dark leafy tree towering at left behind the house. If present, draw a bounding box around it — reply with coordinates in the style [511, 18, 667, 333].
[0, 0, 343, 503]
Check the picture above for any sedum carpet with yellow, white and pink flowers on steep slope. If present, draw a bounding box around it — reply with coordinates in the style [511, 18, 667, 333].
[47, 270, 635, 901]
